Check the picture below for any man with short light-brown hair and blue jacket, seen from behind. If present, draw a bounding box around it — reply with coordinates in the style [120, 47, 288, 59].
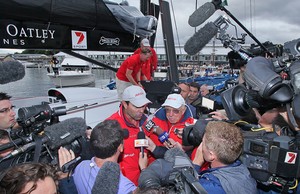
[193, 121, 257, 193]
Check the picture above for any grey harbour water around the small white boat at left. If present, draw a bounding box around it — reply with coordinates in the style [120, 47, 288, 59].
[0, 68, 115, 98]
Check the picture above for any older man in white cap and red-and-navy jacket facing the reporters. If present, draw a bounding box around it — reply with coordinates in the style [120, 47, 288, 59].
[149, 94, 196, 151]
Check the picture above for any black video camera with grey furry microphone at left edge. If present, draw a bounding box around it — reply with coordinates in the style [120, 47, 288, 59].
[0, 104, 88, 171]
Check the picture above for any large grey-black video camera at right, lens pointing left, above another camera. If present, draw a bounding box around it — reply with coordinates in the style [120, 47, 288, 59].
[221, 37, 300, 123]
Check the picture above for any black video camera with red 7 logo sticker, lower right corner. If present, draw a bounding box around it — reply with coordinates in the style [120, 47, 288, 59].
[240, 136, 300, 187]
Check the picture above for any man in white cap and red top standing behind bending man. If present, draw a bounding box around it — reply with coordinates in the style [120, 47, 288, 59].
[134, 38, 157, 80]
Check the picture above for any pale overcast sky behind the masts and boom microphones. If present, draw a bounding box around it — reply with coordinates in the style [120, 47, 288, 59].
[0, 0, 300, 53]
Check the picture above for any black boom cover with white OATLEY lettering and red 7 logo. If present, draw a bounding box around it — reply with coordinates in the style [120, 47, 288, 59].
[0, 20, 139, 52]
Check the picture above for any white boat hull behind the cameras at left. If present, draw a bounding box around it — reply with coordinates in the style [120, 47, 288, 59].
[12, 87, 120, 128]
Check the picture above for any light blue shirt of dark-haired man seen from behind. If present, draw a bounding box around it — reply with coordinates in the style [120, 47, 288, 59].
[73, 158, 136, 194]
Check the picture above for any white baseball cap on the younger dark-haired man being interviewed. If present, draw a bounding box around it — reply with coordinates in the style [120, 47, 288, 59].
[122, 85, 151, 107]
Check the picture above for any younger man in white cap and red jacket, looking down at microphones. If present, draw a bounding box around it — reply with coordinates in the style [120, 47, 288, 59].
[107, 85, 151, 185]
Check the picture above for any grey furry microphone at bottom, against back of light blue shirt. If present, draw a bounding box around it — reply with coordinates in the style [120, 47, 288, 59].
[92, 161, 120, 194]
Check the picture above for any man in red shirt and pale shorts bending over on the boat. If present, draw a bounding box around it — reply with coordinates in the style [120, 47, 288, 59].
[116, 48, 151, 100]
